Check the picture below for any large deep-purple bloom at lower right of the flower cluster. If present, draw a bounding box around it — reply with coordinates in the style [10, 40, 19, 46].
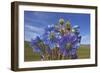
[59, 33, 77, 55]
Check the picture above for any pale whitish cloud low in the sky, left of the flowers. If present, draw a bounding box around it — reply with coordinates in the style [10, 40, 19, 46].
[24, 24, 44, 41]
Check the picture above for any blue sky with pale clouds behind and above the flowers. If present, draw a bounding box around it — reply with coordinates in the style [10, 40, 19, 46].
[24, 11, 90, 44]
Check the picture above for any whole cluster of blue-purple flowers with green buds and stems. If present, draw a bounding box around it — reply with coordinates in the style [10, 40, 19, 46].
[31, 18, 81, 60]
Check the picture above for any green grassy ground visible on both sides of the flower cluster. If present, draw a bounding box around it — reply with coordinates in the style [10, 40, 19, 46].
[24, 41, 90, 61]
